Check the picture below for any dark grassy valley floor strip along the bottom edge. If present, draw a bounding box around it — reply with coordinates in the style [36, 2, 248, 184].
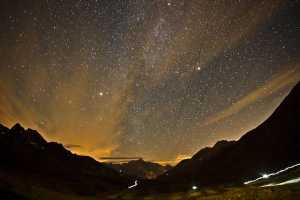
[0, 184, 300, 200]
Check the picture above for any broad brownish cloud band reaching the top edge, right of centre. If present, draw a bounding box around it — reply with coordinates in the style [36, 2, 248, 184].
[141, 0, 282, 86]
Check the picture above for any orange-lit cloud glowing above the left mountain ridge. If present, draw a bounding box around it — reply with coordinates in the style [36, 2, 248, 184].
[0, 66, 135, 158]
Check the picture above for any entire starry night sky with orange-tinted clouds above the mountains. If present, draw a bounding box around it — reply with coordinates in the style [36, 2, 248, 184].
[0, 0, 300, 163]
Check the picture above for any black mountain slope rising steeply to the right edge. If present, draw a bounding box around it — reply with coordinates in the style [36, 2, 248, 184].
[156, 83, 300, 187]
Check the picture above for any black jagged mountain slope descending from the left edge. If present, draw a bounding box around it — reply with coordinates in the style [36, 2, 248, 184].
[0, 124, 129, 195]
